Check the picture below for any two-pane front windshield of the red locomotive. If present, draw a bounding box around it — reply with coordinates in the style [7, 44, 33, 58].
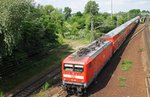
[64, 64, 84, 72]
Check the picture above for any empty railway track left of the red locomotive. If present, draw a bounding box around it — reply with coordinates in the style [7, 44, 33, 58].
[12, 66, 61, 97]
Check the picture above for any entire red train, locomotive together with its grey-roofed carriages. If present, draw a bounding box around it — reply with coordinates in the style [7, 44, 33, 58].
[62, 16, 140, 95]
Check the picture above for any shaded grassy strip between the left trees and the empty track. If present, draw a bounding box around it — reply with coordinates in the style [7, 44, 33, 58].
[0, 39, 89, 93]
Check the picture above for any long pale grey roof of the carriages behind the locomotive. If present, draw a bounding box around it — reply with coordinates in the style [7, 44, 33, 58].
[104, 16, 139, 37]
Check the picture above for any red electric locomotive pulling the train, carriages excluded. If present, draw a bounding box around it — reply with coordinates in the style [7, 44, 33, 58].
[62, 40, 112, 95]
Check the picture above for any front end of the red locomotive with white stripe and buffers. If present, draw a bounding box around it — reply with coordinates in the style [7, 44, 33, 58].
[62, 57, 89, 95]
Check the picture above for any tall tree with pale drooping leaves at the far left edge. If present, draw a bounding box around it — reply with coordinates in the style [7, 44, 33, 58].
[0, 0, 31, 56]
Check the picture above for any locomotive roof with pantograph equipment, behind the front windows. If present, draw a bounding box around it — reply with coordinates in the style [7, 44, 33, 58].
[64, 40, 111, 64]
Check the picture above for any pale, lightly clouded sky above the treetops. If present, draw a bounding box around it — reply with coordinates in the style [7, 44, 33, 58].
[35, 0, 150, 13]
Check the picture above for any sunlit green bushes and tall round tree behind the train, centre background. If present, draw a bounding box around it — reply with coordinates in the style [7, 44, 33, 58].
[62, 1, 132, 39]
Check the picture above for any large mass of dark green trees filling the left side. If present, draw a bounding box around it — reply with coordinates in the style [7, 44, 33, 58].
[0, 0, 63, 90]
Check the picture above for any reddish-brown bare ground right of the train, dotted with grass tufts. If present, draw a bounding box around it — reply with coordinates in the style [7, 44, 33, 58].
[89, 24, 146, 97]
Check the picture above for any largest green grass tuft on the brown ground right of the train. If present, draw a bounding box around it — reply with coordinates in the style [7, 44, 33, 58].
[121, 60, 132, 71]
